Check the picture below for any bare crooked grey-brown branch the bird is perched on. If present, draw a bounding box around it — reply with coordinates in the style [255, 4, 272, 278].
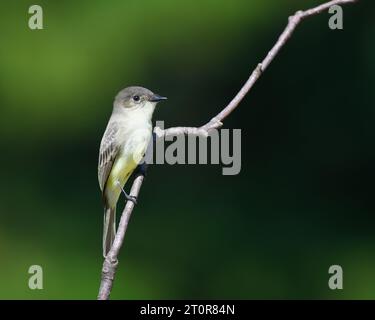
[98, 0, 358, 300]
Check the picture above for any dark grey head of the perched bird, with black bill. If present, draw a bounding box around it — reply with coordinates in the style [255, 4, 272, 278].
[115, 87, 167, 108]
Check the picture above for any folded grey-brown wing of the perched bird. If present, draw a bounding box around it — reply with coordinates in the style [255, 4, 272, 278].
[98, 122, 119, 191]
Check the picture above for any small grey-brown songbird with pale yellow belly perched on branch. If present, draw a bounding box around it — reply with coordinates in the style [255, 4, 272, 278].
[98, 87, 167, 257]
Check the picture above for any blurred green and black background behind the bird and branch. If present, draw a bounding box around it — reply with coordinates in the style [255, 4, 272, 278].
[0, 0, 375, 299]
